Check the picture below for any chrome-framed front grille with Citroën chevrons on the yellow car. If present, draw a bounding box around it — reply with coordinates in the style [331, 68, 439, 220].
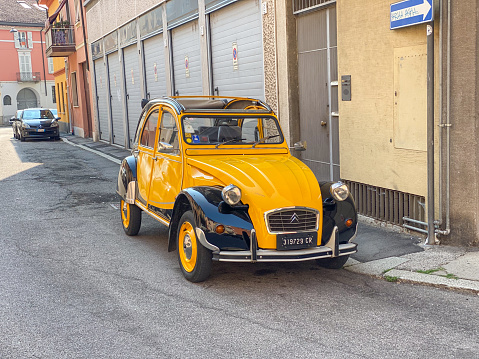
[266, 207, 319, 233]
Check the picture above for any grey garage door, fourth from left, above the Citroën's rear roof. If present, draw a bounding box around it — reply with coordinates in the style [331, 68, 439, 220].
[143, 34, 167, 99]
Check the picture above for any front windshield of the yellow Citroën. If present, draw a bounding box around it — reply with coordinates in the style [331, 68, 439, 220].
[181, 116, 283, 147]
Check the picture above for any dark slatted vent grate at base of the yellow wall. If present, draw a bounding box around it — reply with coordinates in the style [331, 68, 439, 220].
[344, 180, 425, 229]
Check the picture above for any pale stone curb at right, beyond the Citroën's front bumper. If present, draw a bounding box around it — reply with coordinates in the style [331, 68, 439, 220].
[344, 257, 479, 295]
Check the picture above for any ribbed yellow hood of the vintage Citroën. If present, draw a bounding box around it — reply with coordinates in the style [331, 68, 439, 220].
[187, 154, 322, 213]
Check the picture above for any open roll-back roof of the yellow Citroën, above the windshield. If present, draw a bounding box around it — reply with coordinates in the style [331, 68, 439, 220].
[145, 96, 272, 114]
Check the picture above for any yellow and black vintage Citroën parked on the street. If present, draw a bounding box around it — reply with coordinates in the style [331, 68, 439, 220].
[117, 96, 357, 282]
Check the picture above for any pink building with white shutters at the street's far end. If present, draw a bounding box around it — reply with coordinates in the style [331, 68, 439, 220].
[0, 0, 57, 124]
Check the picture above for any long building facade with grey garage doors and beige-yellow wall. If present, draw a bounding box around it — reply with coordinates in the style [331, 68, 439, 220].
[84, 0, 479, 245]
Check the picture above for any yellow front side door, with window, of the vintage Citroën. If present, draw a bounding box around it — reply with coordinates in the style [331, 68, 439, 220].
[148, 107, 183, 216]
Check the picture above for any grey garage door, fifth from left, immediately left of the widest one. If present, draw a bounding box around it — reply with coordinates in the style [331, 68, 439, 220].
[171, 20, 203, 96]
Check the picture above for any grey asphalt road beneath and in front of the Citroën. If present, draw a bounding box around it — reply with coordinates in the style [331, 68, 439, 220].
[0, 128, 479, 358]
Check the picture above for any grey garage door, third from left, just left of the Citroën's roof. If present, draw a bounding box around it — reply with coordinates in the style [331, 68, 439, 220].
[123, 44, 142, 146]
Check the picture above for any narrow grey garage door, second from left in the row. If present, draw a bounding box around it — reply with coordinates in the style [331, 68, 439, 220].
[108, 52, 125, 146]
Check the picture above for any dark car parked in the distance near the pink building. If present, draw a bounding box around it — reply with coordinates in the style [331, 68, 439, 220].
[15, 108, 60, 142]
